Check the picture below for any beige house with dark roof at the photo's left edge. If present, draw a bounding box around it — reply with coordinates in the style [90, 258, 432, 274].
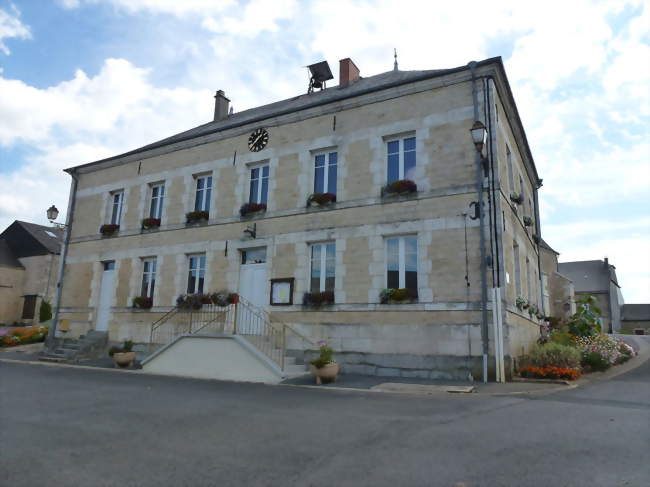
[0, 221, 62, 325]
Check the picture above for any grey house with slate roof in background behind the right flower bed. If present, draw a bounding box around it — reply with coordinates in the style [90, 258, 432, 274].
[558, 257, 623, 333]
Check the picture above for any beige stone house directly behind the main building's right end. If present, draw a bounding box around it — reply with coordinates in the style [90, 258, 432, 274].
[539, 239, 576, 320]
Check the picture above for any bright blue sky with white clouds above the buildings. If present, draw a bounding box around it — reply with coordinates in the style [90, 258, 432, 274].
[0, 0, 650, 303]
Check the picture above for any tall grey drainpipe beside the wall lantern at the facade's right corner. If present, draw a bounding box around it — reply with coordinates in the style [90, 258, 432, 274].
[468, 61, 490, 383]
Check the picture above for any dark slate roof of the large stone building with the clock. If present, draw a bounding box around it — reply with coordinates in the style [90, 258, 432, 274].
[66, 57, 508, 171]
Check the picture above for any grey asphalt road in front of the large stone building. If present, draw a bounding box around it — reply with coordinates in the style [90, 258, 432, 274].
[0, 361, 650, 487]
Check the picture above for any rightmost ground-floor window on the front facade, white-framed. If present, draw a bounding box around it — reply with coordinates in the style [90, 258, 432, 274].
[386, 236, 418, 292]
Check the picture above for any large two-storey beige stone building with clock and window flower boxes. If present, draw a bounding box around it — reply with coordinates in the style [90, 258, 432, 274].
[54, 58, 541, 378]
